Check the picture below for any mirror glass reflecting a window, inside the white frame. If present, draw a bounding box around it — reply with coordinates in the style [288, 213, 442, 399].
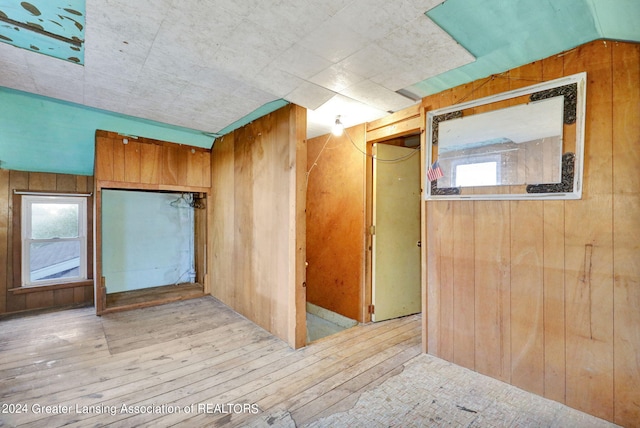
[437, 96, 564, 188]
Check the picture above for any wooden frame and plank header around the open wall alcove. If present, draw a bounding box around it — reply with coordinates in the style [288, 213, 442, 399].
[93, 130, 211, 315]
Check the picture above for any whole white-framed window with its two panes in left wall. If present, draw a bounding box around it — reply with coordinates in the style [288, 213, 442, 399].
[21, 195, 87, 286]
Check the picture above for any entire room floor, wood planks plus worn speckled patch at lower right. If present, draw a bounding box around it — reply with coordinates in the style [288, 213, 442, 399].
[0, 297, 613, 427]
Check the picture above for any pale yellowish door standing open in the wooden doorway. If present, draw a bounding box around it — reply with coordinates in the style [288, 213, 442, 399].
[371, 144, 421, 321]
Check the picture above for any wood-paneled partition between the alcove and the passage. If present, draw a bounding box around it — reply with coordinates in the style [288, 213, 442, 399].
[209, 105, 306, 348]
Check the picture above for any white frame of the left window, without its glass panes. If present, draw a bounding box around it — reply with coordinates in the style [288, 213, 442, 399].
[21, 195, 87, 287]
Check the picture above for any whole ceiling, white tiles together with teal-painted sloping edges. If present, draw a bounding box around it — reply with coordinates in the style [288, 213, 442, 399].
[0, 0, 640, 174]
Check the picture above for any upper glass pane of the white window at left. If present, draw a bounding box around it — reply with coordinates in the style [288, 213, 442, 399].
[31, 203, 79, 239]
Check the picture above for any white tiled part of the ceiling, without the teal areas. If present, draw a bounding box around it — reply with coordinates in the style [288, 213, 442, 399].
[11, 0, 480, 142]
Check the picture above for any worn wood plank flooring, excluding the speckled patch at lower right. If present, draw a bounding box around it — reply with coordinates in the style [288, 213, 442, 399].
[0, 297, 420, 427]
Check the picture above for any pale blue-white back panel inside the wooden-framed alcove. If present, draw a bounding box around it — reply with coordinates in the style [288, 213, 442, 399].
[102, 190, 195, 293]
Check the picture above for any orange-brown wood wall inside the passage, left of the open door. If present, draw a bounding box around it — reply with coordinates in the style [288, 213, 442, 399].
[307, 125, 367, 321]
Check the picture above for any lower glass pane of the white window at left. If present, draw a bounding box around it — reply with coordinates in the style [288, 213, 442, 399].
[29, 241, 80, 282]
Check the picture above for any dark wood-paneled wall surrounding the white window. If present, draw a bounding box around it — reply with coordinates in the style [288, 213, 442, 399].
[0, 169, 93, 314]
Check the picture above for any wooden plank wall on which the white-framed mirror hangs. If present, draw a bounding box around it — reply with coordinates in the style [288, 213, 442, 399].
[423, 41, 640, 426]
